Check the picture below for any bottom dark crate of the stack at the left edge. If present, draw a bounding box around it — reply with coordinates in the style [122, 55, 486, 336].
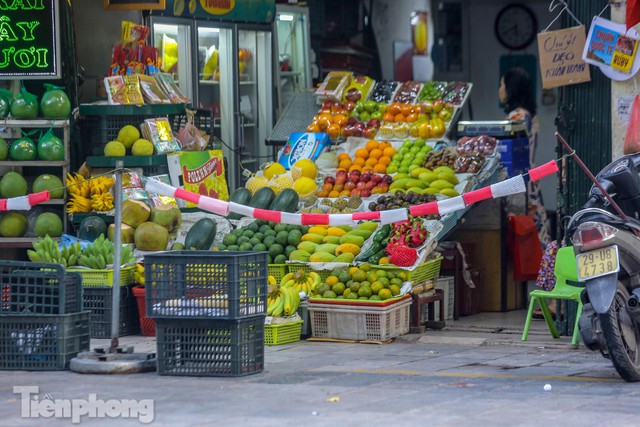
[0, 311, 91, 371]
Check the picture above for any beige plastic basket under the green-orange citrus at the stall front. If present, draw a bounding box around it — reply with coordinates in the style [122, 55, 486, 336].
[309, 298, 411, 341]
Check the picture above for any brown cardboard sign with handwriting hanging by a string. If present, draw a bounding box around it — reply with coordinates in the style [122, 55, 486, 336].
[538, 25, 591, 89]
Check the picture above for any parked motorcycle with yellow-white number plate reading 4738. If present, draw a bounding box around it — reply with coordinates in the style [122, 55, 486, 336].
[567, 154, 640, 382]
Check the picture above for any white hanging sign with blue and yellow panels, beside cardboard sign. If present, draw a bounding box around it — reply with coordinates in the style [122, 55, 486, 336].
[582, 16, 640, 80]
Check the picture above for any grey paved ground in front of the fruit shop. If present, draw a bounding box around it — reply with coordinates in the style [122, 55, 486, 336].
[0, 311, 640, 427]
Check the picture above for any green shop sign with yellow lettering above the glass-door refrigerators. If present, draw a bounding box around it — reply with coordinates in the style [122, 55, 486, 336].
[161, 0, 276, 23]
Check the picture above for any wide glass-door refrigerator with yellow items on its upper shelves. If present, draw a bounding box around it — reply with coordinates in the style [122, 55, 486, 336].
[147, 6, 276, 190]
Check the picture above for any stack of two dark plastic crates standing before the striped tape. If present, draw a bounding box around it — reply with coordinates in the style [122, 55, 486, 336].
[144, 251, 268, 377]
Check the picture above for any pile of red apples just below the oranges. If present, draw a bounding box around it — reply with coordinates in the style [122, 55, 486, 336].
[316, 170, 393, 197]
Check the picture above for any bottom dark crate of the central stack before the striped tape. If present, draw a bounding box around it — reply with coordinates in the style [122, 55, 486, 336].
[156, 315, 265, 377]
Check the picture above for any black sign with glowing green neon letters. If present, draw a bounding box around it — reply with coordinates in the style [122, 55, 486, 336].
[0, 0, 60, 79]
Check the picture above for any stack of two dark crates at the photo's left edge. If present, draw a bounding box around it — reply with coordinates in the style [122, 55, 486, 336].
[0, 261, 90, 371]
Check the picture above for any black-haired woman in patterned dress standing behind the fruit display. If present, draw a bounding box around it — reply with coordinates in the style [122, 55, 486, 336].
[498, 67, 557, 319]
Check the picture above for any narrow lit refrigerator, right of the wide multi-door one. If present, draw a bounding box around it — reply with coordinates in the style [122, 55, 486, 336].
[275, 3, 313, 117]
